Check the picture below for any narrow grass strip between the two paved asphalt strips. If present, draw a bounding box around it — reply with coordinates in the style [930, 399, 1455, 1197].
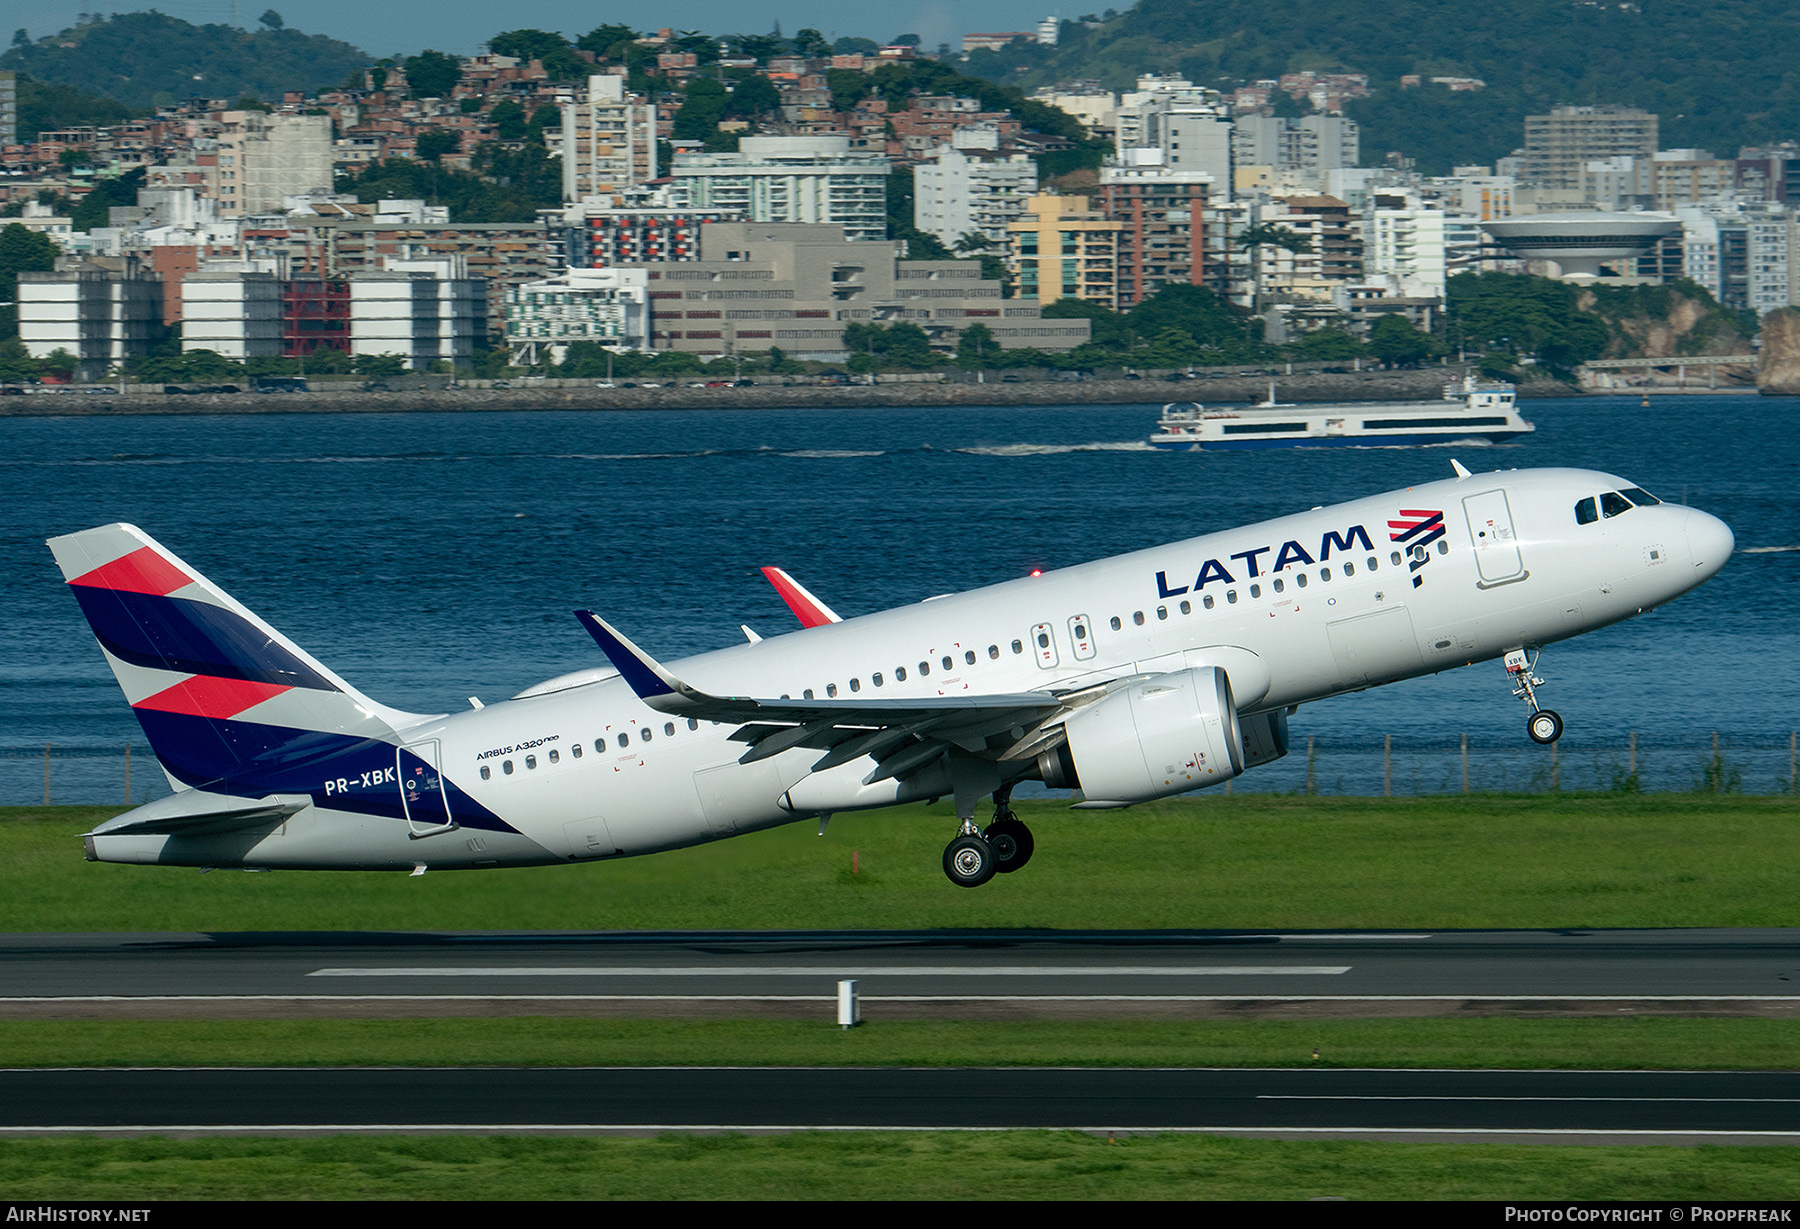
[0, 1002, 1800, 1071]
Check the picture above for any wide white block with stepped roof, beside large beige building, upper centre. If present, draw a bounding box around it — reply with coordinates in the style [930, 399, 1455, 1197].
[671, 137, 889, 241]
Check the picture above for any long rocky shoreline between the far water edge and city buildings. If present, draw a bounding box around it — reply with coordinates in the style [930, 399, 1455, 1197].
[0, 367, 1580, 417]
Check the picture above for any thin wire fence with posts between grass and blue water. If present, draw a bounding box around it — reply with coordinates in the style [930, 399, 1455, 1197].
[0, 731, 1800, 806]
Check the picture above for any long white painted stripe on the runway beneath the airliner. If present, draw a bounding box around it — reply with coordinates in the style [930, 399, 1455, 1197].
[308, 964, 1350, 977]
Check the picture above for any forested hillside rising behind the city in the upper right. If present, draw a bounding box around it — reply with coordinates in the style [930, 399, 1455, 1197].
[968, 0, 1800, 173]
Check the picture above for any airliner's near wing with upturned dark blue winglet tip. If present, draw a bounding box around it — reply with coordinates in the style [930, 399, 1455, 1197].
[576, 610, 1080, 783]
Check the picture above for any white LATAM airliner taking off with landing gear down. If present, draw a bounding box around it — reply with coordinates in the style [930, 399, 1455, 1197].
[50, 464, 1733, 887]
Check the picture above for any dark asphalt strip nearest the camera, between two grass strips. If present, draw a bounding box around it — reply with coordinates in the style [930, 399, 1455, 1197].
[0, 1067, 1800, 1144]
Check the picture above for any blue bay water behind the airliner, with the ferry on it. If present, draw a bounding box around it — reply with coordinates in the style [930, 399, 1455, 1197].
[0, 396, 1800, 803]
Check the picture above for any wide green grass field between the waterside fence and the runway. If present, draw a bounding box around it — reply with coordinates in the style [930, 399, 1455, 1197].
[0, 794, 1800, 932]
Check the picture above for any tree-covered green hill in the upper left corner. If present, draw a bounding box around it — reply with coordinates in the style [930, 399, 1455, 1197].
[0, 9, 369, 110]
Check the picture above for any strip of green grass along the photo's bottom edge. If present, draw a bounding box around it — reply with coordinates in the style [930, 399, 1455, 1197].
[0, 1132, 1800, 1202]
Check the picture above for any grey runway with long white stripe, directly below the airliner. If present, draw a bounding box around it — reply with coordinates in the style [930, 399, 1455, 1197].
[0, 928, 1800, 1017]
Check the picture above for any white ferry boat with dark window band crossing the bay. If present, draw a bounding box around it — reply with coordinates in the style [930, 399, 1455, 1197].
[1150, 376, 1537, 452]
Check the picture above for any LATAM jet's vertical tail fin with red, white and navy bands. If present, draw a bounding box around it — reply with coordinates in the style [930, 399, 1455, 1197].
[49, 524, 419, 797]
